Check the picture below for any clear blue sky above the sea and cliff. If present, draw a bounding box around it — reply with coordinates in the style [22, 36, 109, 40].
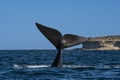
[0, 0, 120, 50]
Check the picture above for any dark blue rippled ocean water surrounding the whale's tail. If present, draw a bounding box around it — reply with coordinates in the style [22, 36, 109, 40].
[0, 50, 120, 80]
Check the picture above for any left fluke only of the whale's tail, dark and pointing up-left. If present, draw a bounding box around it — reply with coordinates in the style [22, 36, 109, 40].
[36, 23, 62, 48]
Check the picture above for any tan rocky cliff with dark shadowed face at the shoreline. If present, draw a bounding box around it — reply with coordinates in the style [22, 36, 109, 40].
[82, 36, 120, 50]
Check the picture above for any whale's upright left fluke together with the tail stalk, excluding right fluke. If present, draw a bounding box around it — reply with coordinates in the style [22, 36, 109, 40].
[36, 23, 62, 67]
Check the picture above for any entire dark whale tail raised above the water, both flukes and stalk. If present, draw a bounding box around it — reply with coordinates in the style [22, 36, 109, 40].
[35, 23, 88, 67]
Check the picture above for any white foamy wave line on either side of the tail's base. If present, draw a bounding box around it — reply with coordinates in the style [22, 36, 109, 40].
[13, 64, 120, 69]
